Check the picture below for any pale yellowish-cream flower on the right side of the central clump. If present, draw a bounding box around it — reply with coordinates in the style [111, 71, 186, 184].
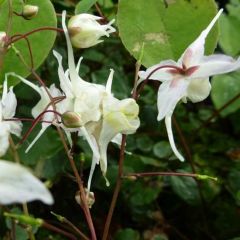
[86, 72, 140, 190]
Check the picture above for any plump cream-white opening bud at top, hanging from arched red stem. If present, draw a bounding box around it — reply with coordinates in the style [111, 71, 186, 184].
[68, 13, 116, 48]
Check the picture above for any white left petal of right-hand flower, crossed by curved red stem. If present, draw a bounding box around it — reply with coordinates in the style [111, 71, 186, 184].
[138, 60, 177, 84]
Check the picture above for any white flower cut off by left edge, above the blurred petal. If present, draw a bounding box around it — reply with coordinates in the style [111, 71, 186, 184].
[0, 81, 22, 156]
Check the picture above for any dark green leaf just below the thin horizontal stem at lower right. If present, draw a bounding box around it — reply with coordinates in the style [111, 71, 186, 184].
[170, 172, 200, 205]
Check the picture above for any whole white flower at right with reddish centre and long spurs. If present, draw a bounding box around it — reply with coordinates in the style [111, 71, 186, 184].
[138, 9, 240, 161]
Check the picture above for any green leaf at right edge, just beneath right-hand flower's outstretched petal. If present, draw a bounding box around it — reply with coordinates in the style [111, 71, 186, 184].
[211, 72, 240, 117]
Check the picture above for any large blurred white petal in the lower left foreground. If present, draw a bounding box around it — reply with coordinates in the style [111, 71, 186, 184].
[0, 160, 53, 204]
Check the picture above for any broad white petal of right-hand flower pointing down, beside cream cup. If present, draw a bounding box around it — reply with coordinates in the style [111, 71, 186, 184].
[157, 79, 189, 121]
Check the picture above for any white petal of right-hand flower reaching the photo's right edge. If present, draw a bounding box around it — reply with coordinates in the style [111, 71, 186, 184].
[191, 54, 240, 78]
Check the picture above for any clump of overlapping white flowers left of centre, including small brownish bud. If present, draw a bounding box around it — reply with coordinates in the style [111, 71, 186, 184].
[6, 11, 140, 190]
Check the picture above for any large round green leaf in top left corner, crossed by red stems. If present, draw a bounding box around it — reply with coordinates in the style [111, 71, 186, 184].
[0, 0, 57, 82]
